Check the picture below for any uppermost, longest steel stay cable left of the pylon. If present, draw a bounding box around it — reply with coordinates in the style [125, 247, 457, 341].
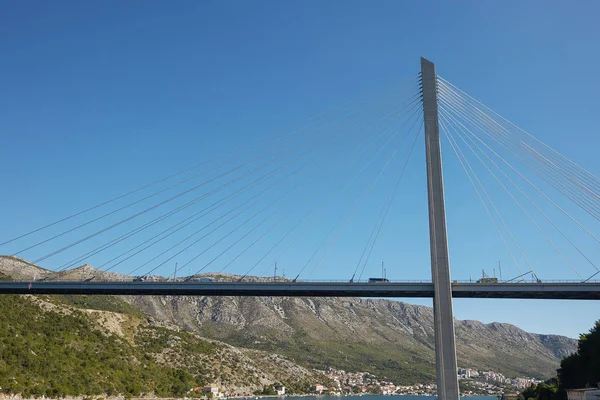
[0, 77, 418, 247]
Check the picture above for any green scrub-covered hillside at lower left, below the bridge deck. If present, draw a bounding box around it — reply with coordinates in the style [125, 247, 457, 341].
[0, 295, 314, 397]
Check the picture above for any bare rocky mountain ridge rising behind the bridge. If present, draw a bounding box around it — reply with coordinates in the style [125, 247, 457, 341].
[0, 258, 576, 384]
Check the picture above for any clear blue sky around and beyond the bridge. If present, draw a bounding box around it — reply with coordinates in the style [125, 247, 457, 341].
[0, 1, 600, 337]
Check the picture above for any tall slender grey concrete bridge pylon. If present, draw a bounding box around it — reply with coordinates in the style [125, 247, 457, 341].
[421, 58, 459, 400]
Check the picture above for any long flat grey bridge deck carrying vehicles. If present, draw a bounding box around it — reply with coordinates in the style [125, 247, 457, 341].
[0, 281, 600, 300]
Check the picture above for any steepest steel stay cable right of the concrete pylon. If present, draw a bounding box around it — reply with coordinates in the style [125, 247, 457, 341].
[440, 113, 533, 273]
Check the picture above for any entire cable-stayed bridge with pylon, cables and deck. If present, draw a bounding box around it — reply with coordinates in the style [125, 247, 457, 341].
[0, 59, 600, 399]
